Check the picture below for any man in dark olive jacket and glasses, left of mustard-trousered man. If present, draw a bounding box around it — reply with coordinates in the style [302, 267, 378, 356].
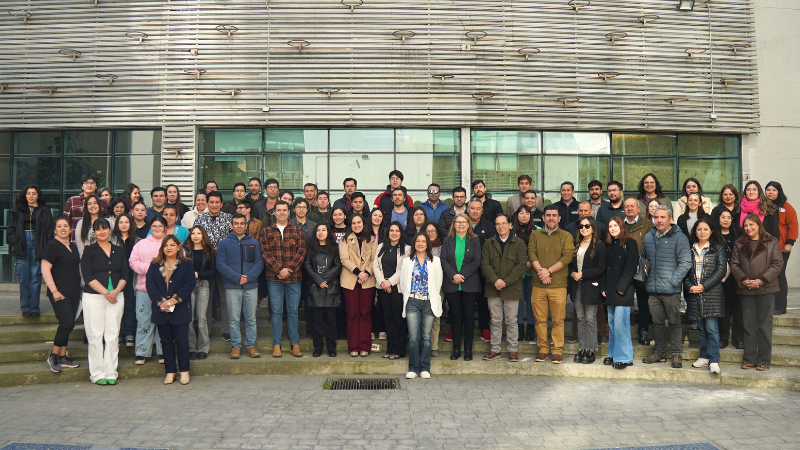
[481, 214, 528, 362]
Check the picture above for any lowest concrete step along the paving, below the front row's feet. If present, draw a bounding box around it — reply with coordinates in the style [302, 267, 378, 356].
[0, 353, 800, 391]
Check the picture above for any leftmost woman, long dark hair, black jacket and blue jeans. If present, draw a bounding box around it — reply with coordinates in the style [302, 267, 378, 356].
[7, 184, 54, 317]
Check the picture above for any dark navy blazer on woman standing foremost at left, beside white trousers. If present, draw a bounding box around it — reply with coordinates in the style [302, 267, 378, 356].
[146, 261, 195, 325]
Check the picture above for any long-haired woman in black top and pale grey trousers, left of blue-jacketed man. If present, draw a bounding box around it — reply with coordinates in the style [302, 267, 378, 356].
[183, 225, 217, 359]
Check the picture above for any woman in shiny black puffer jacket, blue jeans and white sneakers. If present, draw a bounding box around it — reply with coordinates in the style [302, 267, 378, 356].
[683, 217, 728, 374]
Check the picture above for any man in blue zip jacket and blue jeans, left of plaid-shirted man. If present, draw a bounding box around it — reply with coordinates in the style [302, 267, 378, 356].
[217, 213, 264, 359]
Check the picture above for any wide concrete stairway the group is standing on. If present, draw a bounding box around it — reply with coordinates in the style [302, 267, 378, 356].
[0, 310, 800, 391]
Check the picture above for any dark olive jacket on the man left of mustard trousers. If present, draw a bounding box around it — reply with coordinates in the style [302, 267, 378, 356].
[481, 234, 528, 300]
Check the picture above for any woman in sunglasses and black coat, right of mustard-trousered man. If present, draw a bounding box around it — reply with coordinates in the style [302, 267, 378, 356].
[567, 217, 606, 364]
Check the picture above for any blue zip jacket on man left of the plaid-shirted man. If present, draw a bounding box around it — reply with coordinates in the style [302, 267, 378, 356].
[217, 232, 264, 289]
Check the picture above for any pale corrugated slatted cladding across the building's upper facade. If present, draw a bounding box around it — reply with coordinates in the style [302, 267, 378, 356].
[0, 0, 759, 191]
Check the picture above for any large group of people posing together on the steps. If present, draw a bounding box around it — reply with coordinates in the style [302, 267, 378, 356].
[8, 170, 798, 385]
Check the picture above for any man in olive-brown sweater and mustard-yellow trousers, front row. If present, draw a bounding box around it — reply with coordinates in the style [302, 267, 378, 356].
[528, 205, 575, 364]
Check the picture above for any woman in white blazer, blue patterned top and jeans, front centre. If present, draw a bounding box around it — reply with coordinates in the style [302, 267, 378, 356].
[398, 230, 443, 379]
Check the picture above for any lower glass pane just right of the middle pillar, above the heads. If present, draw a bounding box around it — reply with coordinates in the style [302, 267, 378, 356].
[472, 155, 539, 192]
